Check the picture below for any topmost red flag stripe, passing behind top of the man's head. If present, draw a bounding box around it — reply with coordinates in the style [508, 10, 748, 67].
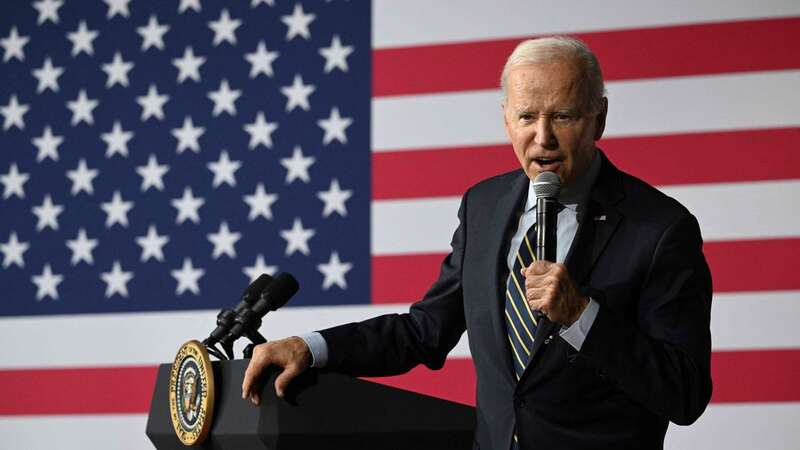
[372, 18, 800, 97]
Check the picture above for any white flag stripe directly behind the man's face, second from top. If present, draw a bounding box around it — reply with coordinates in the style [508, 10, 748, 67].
[372, 69, 800, 152]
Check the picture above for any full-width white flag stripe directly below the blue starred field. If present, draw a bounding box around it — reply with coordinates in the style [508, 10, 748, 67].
[0, 291, 800, 368]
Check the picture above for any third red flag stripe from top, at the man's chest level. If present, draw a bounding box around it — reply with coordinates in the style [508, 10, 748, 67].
[372, 238, 800, 303]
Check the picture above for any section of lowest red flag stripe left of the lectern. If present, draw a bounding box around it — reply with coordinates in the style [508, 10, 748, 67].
[0, 366, 158, 415]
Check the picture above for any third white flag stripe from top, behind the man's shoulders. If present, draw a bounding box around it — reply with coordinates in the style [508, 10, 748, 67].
[372, 180, 800, 255]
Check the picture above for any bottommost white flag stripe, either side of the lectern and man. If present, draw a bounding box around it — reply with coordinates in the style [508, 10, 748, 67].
[0, 402, 800, 450]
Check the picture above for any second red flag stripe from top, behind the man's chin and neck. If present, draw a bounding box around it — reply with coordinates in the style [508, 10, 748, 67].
[372, 128, 800, 200]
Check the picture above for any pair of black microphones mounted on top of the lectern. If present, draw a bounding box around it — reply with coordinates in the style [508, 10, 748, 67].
[220, 272, 300, 346]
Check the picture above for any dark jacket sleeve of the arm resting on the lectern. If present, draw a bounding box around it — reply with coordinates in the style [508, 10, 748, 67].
[320, 193, 468, 376]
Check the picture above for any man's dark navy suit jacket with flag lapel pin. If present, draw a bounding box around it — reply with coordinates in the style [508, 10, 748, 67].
[321, 153, 711, 450]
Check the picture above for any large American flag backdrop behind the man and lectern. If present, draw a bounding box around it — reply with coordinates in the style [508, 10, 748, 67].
[0, 0, 800, 450]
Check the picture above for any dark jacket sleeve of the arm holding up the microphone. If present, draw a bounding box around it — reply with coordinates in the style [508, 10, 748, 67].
[580, 214, 712, 425]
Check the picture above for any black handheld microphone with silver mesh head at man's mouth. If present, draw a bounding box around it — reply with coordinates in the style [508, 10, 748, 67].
[533, 172, 561, 262]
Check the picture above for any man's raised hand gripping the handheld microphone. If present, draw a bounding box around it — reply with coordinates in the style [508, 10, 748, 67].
[520, 261, 589, 327]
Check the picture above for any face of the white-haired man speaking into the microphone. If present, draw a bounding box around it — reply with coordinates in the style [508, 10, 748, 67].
[503, 61, 606, 186]
